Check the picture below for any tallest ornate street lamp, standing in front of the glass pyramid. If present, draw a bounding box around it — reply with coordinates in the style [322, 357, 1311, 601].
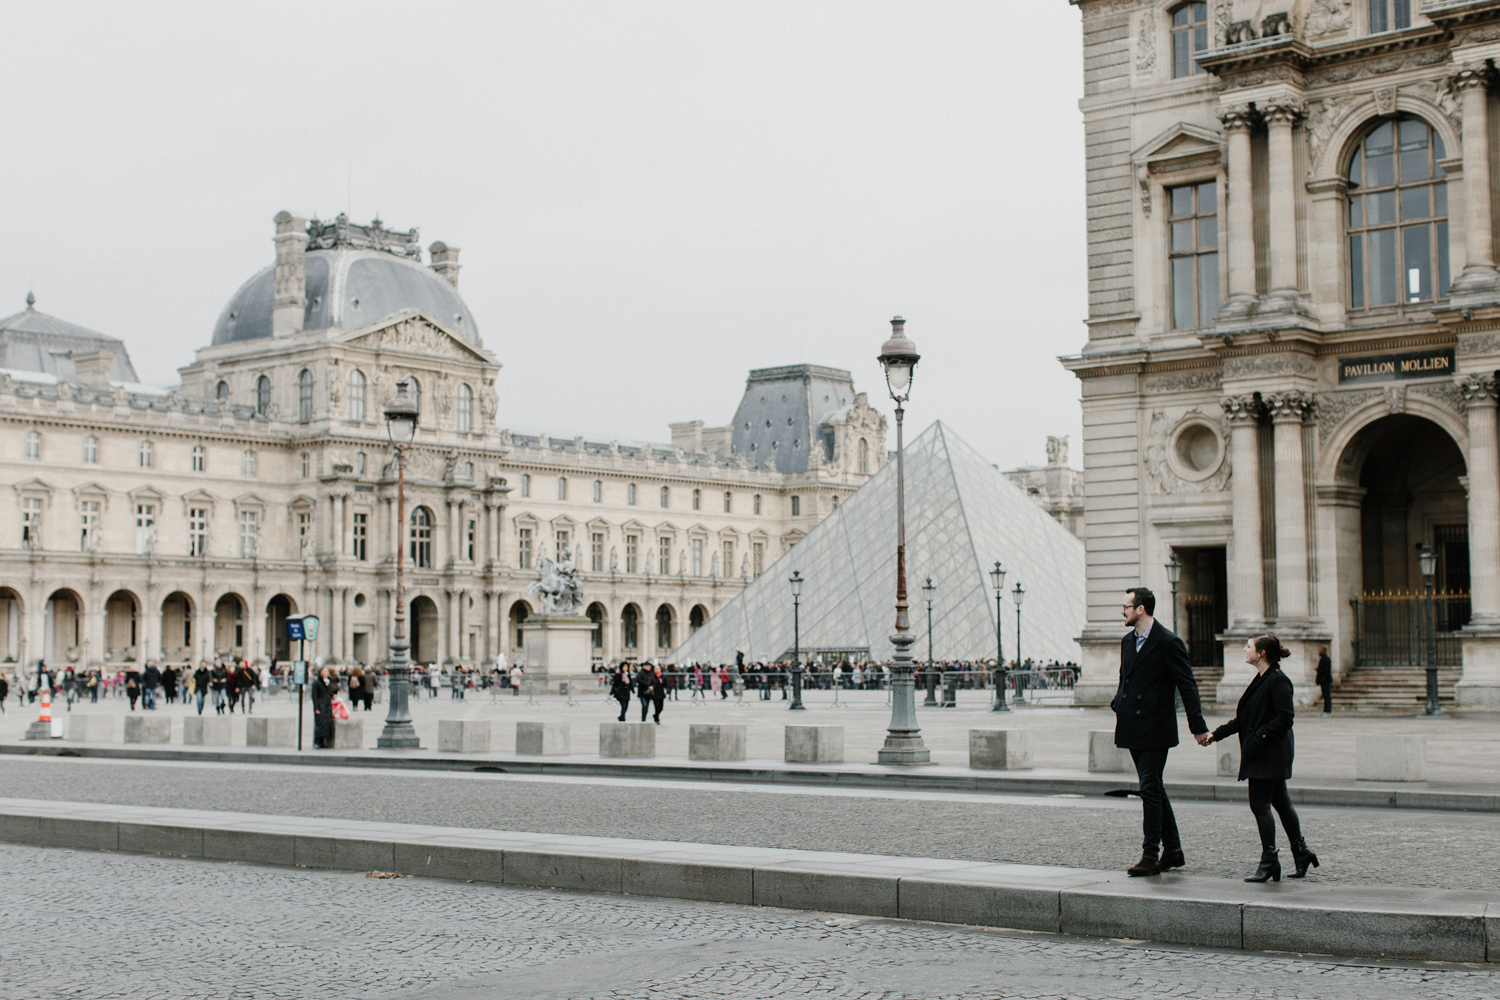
[876, 316, 932, 765]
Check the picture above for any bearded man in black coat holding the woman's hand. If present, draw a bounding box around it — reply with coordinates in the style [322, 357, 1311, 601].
[1110, 586, 1209, 876]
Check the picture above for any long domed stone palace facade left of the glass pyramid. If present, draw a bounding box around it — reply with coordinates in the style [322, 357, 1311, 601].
[0, 213, 887, 677]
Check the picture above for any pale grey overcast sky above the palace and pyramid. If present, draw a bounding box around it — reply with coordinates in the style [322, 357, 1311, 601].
[0, 0, 1086, 468]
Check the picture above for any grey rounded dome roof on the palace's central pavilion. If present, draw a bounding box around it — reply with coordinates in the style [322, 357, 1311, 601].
[213, 246, 483, 346]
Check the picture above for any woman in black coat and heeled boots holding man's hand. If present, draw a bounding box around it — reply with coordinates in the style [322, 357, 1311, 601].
[1199, 633, 1319, 882]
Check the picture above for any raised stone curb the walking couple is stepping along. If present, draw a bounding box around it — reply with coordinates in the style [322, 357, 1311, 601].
[0, 799, 1500, 963]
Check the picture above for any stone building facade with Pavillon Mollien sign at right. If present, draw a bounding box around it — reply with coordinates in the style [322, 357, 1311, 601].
[1064, 0, 1500, 708]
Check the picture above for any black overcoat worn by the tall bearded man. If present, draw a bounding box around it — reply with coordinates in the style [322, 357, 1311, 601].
[1110, 622, 1209, 750]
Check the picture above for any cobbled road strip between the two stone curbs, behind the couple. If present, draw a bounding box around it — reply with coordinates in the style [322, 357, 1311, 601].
[0, 757, 1500, 889]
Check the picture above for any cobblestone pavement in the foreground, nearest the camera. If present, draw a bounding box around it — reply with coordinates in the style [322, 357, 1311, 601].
[0, 844, 1500, 1000]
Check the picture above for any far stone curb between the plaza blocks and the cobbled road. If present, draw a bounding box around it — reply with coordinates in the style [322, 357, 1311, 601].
[0, 741, 1500, 813]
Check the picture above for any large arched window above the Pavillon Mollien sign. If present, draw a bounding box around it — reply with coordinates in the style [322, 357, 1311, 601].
[1349, 117, 1448, 309]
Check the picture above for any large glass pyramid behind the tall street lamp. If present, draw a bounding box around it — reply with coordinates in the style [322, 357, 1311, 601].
[672, 423, 1086, 663]
